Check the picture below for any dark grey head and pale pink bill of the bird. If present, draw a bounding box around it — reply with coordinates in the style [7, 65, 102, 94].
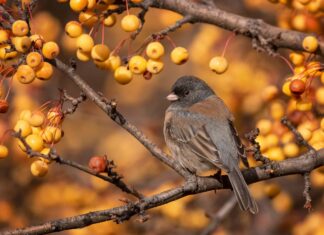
[167, 76, 215, 107]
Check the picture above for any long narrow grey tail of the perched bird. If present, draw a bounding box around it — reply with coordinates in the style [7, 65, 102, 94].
[228, 167, 258, 214]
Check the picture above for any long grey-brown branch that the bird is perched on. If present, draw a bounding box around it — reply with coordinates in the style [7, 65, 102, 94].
[2, 149, 324, 235]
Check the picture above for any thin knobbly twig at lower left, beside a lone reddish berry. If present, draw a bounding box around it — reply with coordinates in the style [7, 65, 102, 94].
[12, 132, 143, 199]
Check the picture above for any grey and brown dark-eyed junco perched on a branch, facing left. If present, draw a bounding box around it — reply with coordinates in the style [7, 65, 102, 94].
[164, 76, 258, 214]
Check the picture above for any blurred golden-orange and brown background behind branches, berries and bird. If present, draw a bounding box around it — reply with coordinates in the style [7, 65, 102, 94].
[0, 0, 324, 235]
